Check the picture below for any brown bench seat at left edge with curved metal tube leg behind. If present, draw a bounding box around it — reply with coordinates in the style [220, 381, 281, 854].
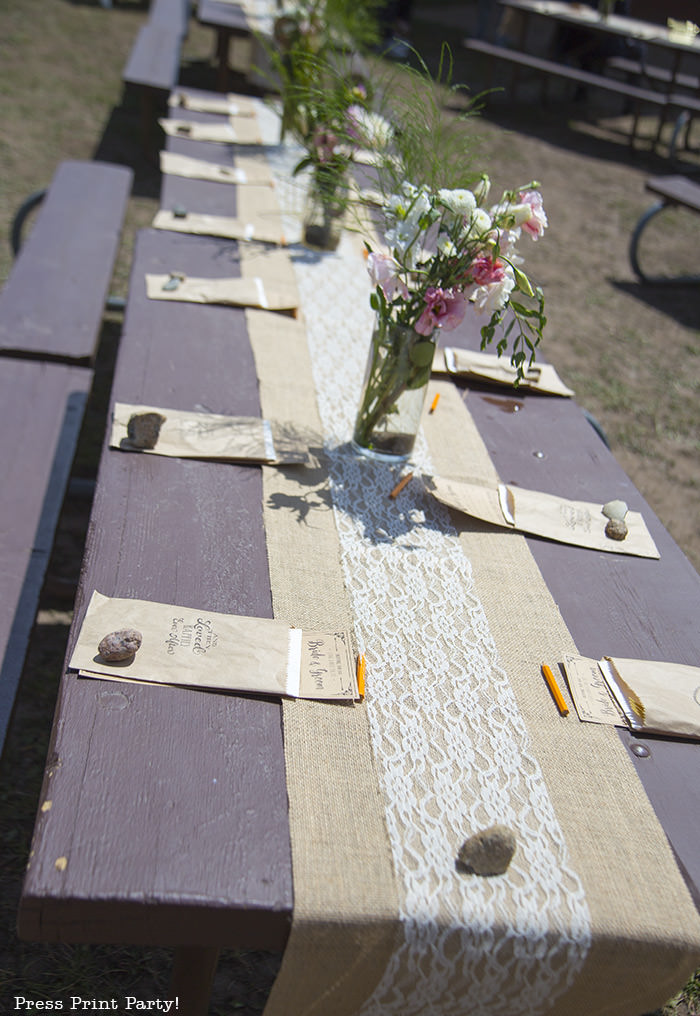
[0, 161, 133, 364]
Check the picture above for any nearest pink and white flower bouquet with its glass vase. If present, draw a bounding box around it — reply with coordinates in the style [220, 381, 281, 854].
[353, 48, 547, 458]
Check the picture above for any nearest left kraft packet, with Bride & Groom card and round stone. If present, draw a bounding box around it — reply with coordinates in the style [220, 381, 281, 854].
[68, 590, 360, 701]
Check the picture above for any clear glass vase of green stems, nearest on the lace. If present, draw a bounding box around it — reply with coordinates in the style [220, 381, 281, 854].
[353, 314, 435, 461]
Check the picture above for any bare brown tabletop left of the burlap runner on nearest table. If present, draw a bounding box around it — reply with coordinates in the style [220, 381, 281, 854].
[19, 231, 292, 948]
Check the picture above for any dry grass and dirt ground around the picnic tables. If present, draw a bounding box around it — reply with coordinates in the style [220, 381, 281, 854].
[0, 0, 700, 1016]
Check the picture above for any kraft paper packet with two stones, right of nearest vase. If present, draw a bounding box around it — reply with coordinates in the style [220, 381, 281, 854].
[426, 477, 659, 558]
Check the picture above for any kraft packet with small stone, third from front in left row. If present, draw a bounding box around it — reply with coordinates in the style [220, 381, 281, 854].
[146, 270, 299, 311]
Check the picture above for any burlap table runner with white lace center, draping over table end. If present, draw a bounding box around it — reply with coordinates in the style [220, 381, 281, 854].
[237, 97, 700, 1016]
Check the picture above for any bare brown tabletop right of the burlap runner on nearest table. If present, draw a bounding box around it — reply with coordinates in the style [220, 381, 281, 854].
[442, 328, 700, 906]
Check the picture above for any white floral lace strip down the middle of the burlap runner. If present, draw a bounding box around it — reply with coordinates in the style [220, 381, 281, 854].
[257, 103, 590, 1016]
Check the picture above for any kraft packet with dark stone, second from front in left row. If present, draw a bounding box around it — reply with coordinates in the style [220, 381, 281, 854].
[110, 402, 308, 464]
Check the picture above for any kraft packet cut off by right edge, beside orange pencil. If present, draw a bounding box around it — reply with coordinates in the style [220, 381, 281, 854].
[565, 656, 700, 740]
